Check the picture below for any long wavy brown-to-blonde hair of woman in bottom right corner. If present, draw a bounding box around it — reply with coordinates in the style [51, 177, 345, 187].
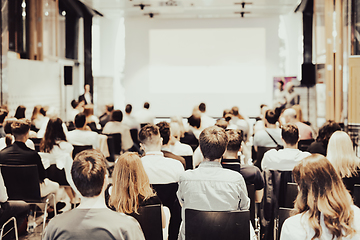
[293, 154, 355, 239]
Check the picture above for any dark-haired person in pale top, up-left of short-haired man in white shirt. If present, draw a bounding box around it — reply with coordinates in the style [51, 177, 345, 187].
[103, 110, 134, 151]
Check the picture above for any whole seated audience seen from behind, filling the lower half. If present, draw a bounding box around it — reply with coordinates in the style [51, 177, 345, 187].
[0, 100, 360, 240]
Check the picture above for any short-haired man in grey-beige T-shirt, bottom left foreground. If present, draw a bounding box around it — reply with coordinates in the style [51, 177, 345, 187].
[43, 150, 145, 240]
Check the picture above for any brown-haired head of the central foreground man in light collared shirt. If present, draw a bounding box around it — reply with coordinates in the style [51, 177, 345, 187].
[199, 126, 228, 161]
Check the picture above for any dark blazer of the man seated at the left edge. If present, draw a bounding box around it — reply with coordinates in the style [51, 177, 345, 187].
[0, 142, 45, 182]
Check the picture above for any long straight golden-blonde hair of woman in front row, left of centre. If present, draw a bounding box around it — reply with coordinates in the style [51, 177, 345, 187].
[109, 152, 155, 214]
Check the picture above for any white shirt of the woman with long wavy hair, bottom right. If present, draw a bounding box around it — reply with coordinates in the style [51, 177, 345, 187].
[280, 205, 360, 240]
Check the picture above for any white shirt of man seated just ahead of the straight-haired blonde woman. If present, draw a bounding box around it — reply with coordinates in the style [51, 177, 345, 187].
[141, 152, 184, 184]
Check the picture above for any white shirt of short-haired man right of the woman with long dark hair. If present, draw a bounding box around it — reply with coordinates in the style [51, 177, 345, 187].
[66, 129, 99, 148]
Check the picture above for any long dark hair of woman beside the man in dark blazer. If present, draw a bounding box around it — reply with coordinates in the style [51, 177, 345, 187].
[40, 118, 66, 153]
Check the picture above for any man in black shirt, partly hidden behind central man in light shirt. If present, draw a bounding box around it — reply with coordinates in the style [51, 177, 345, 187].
[221, 129, 264, 203]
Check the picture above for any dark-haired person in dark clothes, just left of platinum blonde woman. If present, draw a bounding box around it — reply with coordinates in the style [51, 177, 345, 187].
[307, 120, 341, 156]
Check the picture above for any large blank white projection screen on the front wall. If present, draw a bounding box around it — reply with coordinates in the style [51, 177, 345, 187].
[149, 28, 266, 96]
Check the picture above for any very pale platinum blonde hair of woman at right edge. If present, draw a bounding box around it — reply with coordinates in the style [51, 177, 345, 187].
[326, 131, 360, 178]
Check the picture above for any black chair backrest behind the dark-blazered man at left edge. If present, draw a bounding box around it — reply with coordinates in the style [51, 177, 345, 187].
[0, 164, 41, 202]
